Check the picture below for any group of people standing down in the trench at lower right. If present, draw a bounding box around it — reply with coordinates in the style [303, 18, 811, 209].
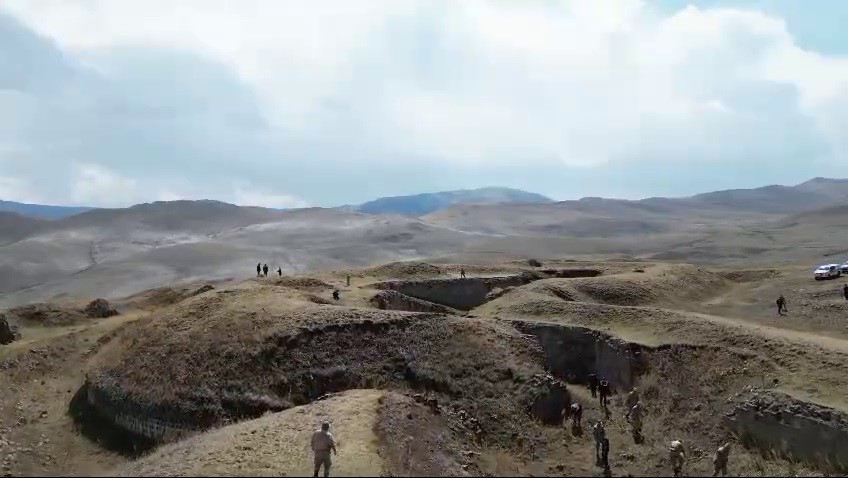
[580, 380, 730, 476]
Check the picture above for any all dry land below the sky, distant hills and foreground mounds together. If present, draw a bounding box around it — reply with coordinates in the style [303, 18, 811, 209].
[0, 179, 848, 476]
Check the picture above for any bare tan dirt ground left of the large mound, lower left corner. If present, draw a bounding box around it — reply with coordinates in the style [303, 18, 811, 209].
[0, 313, 140, 475]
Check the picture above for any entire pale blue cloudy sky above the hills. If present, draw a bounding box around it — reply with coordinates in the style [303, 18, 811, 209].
[0, 0, 848, 207]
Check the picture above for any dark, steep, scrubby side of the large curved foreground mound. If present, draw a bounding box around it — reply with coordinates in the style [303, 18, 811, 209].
[69, 314, 570, 456]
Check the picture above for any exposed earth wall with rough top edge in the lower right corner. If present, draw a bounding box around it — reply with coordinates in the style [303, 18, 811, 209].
[725, 392, 848, 472]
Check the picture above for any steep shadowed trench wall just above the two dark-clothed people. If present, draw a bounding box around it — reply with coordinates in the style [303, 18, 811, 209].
[513, 321, 647, 390]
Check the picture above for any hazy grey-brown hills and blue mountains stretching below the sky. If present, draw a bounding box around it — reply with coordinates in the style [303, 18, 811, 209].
[0, 178, 848, 306]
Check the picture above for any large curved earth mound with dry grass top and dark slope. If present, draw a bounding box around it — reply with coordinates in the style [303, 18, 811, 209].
[81, 288, 569, 456]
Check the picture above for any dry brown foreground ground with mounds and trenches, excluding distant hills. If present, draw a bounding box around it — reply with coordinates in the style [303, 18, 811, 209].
[0, 254, 848, 476]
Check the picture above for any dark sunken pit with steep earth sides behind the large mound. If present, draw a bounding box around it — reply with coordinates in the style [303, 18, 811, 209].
[370, 269, 601, 311]
